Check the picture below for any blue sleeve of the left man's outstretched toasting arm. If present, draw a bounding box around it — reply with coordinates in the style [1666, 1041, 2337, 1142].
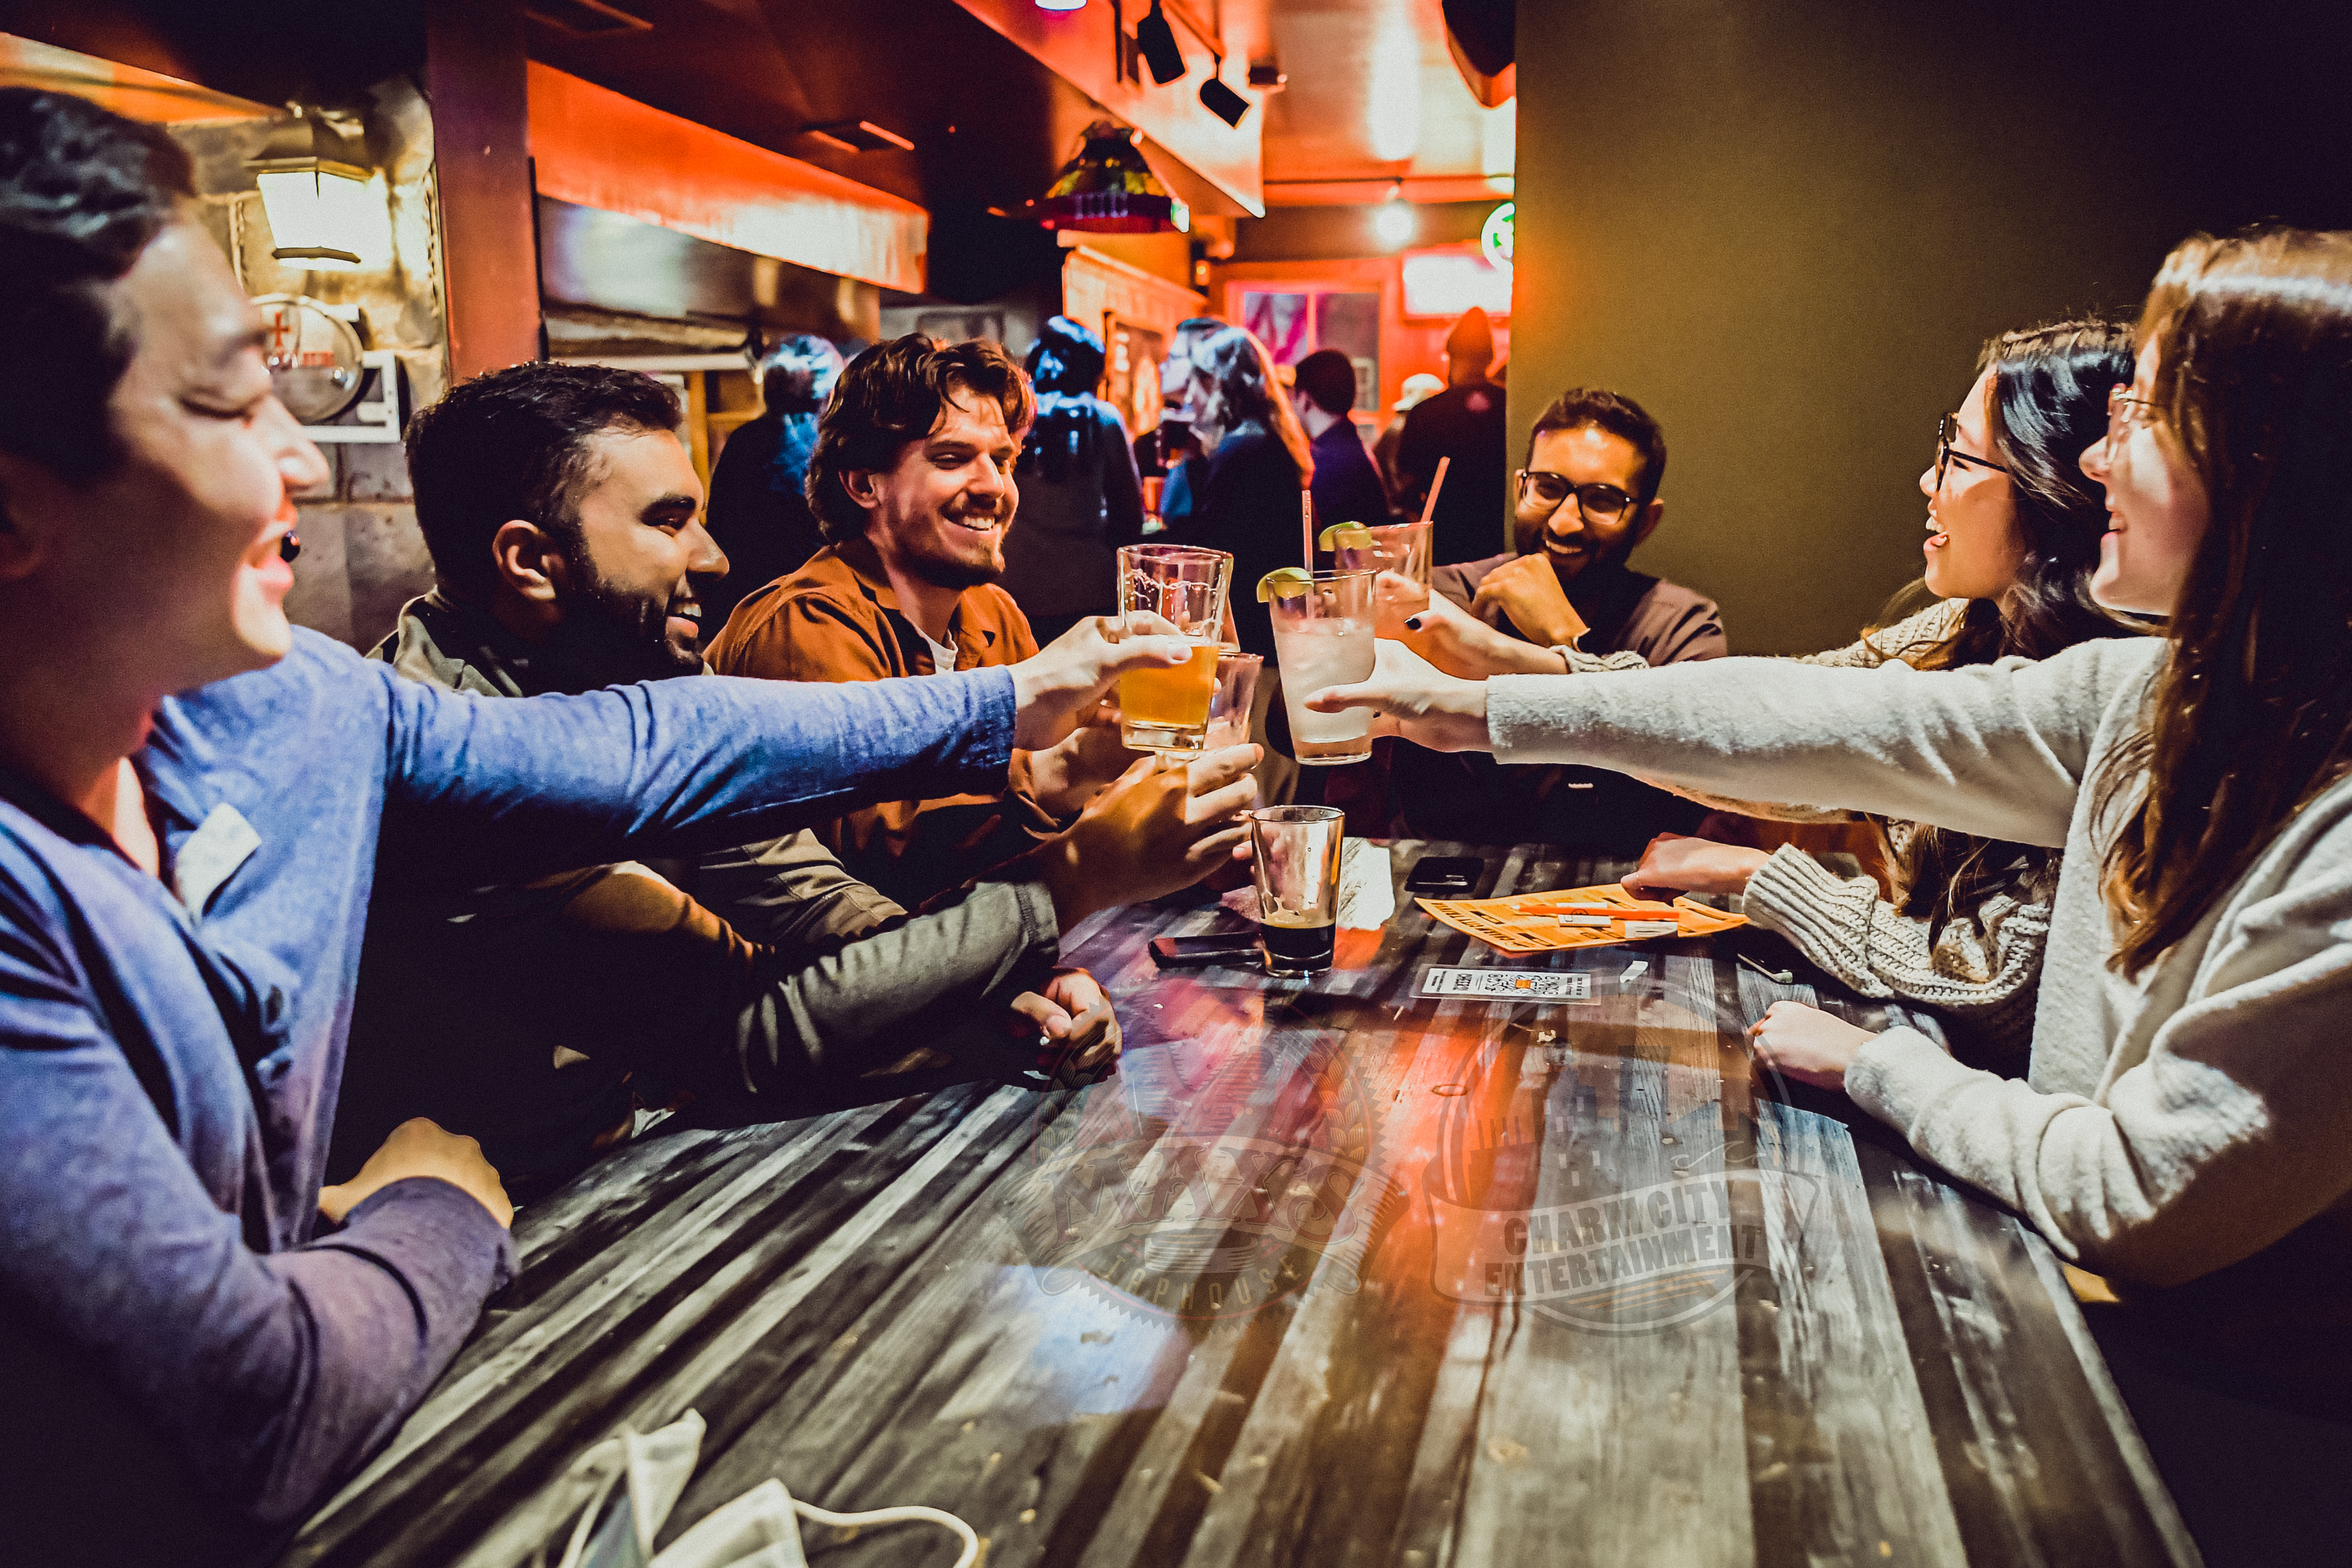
[376, 665, 1014, 886]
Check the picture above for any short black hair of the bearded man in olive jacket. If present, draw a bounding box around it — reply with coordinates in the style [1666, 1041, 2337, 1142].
[409, 362, 682, 597]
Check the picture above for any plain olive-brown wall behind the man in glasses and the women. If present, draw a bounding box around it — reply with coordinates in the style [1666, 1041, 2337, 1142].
[1510, 0, 2352, 654]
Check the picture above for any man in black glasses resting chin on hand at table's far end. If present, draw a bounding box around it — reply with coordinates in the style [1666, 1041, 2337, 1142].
[1390, 388, 1727, 855]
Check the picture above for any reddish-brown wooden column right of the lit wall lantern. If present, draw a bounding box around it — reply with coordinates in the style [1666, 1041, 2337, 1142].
[426, 0, 538, 381]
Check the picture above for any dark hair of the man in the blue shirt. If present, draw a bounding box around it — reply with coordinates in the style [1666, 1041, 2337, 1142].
[0, 87, 193, 480]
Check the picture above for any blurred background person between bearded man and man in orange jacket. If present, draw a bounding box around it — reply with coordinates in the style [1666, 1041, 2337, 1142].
[703, 332, 842, 637]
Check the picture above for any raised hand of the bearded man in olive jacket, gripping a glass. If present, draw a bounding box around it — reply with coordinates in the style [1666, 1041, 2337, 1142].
[1030, 745, 1263, 931]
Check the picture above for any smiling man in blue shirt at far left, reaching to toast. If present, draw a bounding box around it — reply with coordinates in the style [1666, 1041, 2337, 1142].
[0, 89, 1213, 1563]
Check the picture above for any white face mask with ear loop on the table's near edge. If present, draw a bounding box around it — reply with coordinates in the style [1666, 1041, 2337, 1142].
[538, 1410, 981, 1568]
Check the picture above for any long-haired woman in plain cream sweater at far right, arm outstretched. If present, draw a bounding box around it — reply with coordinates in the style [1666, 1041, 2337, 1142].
[1312, 231, 2352, 1316]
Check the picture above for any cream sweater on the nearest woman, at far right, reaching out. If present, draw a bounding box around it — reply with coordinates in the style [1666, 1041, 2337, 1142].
[1486, 637, 2352, 1286]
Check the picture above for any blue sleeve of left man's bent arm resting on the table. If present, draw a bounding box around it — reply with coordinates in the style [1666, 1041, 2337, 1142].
[0, 949, 510, 1523]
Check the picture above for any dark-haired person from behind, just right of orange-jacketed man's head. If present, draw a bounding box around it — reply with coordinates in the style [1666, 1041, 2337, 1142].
[1002, 315, 1143, 642]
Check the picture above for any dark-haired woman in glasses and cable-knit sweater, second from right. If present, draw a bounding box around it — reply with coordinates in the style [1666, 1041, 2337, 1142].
[1407, 322, 2131, 1063]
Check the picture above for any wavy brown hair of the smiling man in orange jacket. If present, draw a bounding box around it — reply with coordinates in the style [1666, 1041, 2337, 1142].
[809, 332, 1037, 545]
